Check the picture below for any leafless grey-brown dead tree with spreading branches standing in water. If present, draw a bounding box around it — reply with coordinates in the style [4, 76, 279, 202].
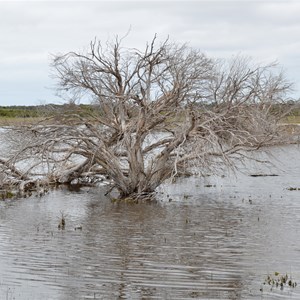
[1, 37, 291, 197]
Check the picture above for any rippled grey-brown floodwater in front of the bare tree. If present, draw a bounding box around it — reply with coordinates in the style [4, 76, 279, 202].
[0, 145, 300, 300]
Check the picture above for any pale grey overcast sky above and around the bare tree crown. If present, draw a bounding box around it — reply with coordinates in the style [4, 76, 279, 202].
[0, 0, 300, 106]
